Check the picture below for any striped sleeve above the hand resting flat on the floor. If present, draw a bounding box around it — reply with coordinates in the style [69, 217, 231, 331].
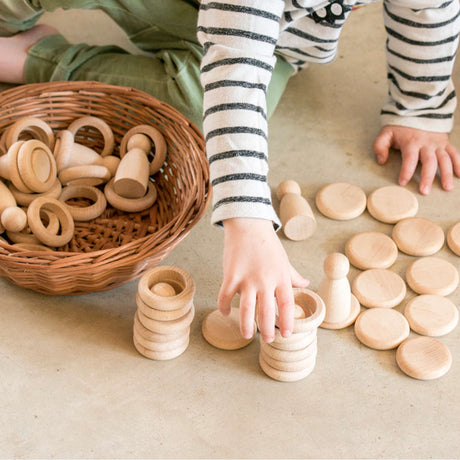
[382, 0, 460, 133]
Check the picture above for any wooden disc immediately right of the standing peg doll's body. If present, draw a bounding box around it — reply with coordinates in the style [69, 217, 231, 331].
[351, 268, 406, 308]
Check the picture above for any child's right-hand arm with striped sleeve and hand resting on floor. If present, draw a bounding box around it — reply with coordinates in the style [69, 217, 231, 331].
[374, 0, 460, 190]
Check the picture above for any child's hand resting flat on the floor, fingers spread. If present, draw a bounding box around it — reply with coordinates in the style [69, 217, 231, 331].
[373, 125, 460, 195]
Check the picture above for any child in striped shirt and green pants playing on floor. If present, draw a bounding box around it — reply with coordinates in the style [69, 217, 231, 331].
[0, 0, 460, 342]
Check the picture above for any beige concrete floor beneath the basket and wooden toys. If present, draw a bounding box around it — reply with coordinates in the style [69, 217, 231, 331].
[0, 4, 460, 459]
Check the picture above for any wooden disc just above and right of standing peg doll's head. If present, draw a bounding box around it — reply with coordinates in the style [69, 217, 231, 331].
[345, 232, 398, 270]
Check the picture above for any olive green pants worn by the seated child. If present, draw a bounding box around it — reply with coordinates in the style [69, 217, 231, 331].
[0, 0, 293, 128]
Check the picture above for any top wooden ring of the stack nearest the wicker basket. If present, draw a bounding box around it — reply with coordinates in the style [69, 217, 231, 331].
[137, 265, 195, 311]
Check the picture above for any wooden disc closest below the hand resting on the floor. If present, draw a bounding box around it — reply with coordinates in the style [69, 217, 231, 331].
[367, 185, 418, 224]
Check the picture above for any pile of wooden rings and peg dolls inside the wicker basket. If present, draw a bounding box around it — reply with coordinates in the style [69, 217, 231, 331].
[0, 116, 167, 250]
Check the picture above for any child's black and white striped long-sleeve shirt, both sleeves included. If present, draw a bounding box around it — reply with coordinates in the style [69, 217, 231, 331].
[198, 0, 460, 226]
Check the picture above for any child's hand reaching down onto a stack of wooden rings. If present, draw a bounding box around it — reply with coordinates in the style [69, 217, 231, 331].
[218, 218, 309, 342]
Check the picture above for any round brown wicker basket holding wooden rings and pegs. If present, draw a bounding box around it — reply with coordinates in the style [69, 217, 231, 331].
[0, 82, 210, 295]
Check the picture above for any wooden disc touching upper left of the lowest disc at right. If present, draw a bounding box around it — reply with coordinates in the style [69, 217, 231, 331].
[355, 308, 410, 350]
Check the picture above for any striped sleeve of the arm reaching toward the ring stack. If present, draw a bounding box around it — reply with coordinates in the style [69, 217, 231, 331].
[198, 0, 284, 226]
